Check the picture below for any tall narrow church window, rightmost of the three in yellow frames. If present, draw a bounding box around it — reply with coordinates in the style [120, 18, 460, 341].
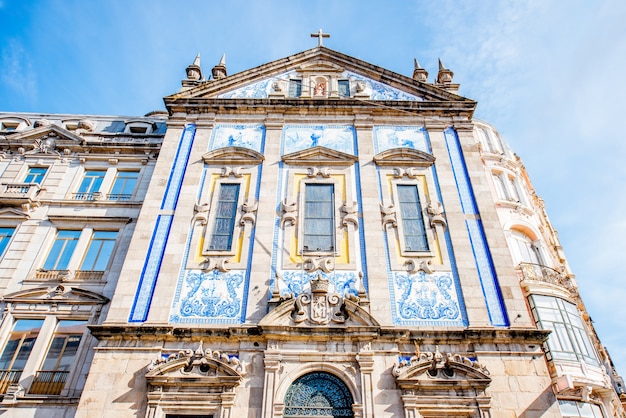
[397, 185, 428, 251]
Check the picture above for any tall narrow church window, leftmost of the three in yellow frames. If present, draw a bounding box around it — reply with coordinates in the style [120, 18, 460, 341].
[209, 183, 239, 251]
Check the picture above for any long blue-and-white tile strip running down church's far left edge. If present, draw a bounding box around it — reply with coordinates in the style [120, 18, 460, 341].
[128, 123, 196, 322]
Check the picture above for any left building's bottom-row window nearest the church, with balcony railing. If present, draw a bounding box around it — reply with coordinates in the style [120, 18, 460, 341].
[28, 320, 87, 395]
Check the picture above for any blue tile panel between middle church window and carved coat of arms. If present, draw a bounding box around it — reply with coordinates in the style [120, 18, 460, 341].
[278, 270, 359, 297]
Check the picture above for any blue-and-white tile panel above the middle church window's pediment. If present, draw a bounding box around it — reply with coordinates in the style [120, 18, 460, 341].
[281, 125, 356, 155]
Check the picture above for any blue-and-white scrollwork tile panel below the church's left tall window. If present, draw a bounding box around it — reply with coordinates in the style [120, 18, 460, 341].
[169, 270, 246, 324]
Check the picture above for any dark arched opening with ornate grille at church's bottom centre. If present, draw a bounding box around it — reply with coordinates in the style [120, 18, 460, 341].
[284, 372, 354, 418]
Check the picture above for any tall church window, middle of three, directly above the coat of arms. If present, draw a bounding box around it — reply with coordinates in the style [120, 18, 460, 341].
[302, 183, 335, 253]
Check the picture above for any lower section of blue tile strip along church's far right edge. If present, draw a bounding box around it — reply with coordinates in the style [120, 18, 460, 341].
[465, 219, 509, 326]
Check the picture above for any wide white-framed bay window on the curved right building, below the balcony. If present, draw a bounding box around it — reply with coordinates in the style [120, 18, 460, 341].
[529, 295, 598, 366]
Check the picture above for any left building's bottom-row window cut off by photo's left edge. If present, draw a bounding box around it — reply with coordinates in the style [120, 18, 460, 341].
[0, 319, 43, 393]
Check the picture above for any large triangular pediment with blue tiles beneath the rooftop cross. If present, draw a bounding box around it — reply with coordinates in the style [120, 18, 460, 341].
[165, 46, 475, 106]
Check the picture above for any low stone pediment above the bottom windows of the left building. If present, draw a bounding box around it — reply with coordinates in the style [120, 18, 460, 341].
[3, 285, 109, 305]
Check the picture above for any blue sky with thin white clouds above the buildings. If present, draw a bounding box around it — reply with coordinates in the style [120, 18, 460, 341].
[0, 0, 626, 374]
